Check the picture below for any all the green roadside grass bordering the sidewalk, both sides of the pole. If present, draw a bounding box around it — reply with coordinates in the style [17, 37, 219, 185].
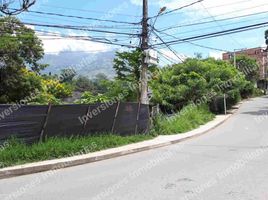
[0, 106, 214, 168]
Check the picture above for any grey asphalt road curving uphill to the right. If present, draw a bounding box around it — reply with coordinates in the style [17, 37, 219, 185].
[0, 97, 268, 200]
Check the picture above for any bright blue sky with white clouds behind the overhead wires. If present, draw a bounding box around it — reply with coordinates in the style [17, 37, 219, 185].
[7, 0, 268, 62]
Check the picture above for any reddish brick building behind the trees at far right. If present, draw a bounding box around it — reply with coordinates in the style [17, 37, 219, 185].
[222, 47, 268, 80]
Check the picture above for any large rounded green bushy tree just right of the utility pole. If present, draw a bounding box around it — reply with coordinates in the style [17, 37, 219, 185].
[150, 58, 254, 112]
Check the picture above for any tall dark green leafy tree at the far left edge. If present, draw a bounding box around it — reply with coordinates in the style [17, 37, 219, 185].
[0, 17, 46, 103]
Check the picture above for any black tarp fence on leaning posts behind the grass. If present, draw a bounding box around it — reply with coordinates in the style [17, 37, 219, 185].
[0, 102, 150, 144]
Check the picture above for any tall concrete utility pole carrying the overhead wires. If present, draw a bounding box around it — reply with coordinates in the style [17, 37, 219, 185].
[140, 0, 149, 104]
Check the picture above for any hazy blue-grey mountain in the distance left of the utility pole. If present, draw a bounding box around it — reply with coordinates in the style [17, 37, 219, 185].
[42, 51, 115, 78]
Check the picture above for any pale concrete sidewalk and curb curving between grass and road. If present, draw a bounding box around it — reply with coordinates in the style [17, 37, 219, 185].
[0, 103, 242, 179]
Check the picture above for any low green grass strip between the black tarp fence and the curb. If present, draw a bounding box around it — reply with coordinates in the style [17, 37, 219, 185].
[0, 133, 153, 168]
